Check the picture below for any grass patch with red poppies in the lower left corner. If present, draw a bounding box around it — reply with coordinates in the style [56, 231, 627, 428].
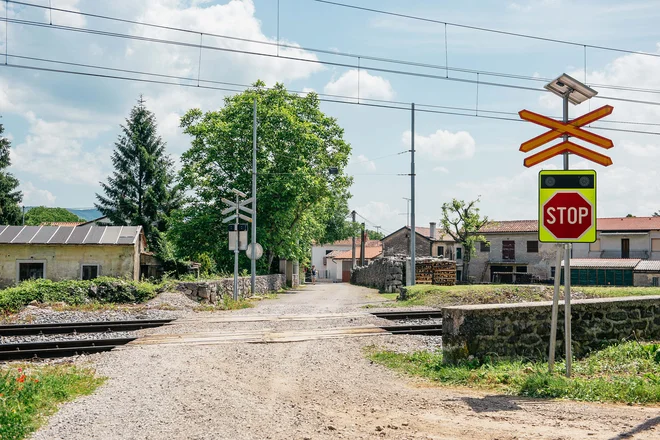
[0, 365, 105, 440]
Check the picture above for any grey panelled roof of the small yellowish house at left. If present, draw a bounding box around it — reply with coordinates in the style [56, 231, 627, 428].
[0, 225, 142, 245]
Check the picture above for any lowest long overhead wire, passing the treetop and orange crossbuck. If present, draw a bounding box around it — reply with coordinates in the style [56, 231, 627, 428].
[5, 59, 660, 137]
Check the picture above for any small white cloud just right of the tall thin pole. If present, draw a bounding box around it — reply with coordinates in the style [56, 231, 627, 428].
[401, 130, 476, 160]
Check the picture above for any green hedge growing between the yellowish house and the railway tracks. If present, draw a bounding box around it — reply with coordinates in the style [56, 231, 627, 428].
[0, 277, 161, 312]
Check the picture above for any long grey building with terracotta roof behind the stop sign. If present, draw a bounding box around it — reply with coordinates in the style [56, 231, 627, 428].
[470, 217, 660, 285]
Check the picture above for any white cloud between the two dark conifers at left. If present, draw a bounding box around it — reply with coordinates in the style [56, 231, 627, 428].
[11, 113, 110, 185]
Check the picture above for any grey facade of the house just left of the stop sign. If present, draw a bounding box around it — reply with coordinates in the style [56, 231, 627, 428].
[469, 232, 557, 282]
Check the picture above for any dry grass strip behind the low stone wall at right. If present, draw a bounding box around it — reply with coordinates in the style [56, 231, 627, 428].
[396, 284, 660, 307]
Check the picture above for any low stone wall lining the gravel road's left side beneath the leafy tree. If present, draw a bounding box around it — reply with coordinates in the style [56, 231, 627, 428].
[176, 274, 286, 304]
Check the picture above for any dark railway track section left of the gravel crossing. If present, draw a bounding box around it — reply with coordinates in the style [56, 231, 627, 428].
[0, 319, 173, 361]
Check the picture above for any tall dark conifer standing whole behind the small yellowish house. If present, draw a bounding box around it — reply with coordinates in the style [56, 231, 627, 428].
[96, 96, 181, 250]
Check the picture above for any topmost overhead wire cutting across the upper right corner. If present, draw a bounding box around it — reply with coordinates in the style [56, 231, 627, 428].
[312, 0, 660, 57]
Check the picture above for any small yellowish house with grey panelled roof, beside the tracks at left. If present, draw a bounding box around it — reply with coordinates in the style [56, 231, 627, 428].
[0, 225, 146, 287]
